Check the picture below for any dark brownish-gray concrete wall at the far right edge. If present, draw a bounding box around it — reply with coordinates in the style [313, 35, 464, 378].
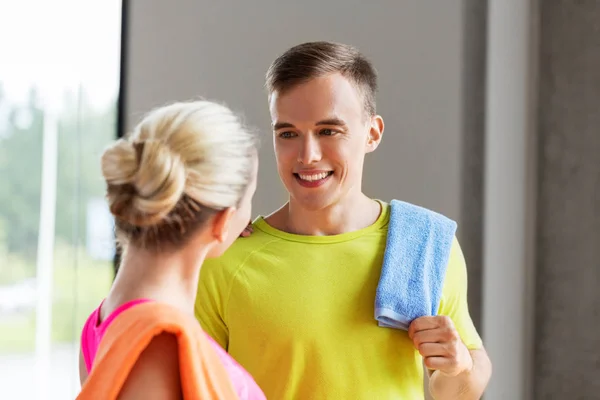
[535, 0, 600, 400]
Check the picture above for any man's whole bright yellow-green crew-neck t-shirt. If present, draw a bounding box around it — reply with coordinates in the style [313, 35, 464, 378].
[196, 203, 482, 400]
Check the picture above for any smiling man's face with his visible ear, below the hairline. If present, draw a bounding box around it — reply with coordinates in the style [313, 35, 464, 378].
[269, 74, 383, 210]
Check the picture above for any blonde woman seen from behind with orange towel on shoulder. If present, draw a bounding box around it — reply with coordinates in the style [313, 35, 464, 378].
[80, 101, 264, 399]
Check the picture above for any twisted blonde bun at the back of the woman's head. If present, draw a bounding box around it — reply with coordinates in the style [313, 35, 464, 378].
[102, 140, 186, 227]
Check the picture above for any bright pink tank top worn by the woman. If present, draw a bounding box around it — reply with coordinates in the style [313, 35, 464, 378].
[81, 299, 266, 400]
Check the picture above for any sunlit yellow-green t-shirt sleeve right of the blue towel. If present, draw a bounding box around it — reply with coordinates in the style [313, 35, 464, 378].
[439, 238, 483, 350]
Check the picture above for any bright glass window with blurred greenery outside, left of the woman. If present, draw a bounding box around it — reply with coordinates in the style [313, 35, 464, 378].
[0, 0, 121, 400]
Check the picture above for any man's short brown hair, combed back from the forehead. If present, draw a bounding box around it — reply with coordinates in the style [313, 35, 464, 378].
[266, 42, 377, 115]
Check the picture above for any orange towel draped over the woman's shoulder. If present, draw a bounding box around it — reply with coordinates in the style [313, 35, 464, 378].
[77, 302, 238, 400]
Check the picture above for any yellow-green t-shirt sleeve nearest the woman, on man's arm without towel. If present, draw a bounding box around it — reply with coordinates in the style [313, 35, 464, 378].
[194, 258, 229, 350]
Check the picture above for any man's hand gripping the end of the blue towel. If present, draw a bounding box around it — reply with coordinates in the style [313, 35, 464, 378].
[408, 316, 473, 377]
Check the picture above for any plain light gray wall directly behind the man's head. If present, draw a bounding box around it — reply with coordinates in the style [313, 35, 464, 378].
[126, 0, 463, 222]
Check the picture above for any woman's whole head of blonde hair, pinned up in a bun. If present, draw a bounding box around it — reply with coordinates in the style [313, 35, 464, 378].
[102, 101, 256, 248]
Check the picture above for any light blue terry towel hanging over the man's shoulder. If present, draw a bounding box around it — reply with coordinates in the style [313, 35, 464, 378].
[375, 200, 456, 330]
